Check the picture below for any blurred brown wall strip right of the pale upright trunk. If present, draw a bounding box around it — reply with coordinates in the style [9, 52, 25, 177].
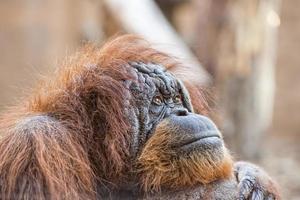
[273, 0, 300, 135]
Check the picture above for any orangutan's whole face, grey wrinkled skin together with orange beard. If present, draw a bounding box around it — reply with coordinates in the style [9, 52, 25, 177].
[122, 63, 232, 191]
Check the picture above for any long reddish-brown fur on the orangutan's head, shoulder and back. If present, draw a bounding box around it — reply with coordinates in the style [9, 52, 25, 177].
[0, 36, 216, 199]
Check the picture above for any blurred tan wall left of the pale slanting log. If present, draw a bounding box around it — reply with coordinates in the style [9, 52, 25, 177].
[0, 0, 99, 109]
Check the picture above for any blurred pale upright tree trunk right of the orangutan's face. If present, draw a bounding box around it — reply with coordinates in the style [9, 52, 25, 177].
[195, 0, 280, 159]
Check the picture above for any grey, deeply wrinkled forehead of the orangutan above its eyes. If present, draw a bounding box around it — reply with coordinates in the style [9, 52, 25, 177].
[130, 62, 178, 95]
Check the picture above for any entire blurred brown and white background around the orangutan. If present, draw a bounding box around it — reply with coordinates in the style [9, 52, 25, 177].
[0, 0, 300, 200]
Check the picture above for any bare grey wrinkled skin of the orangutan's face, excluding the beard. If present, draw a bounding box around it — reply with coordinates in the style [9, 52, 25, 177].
[127, 62, 223, 155]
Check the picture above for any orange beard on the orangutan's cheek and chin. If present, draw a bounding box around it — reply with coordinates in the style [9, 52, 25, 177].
[138, 120, 233, 191]
